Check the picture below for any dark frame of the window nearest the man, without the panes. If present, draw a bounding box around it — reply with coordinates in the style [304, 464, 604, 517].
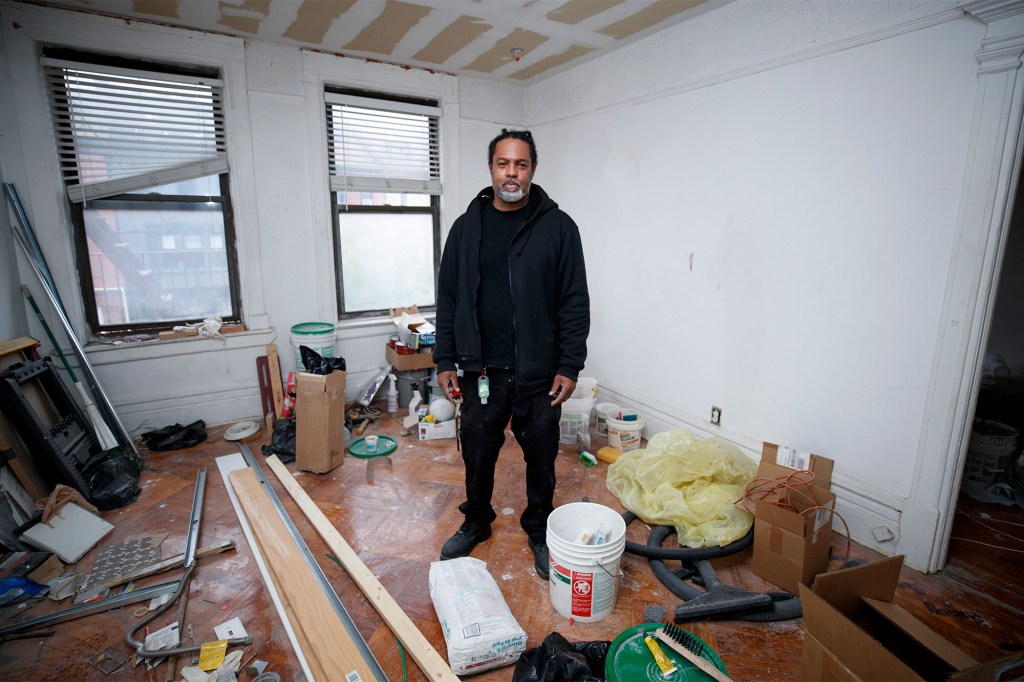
[324, 85, 444, 321]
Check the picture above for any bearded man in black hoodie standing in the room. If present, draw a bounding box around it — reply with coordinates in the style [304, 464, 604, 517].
[434, 125, 590, 580]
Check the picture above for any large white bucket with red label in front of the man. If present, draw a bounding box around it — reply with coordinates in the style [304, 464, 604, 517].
[548, 502, 626, 623]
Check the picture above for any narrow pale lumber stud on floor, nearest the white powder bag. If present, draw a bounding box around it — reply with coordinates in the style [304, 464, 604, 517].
[266, 455, 459, 682]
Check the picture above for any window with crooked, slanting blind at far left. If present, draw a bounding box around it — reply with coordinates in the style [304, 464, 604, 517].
[43, 48, 241, 334]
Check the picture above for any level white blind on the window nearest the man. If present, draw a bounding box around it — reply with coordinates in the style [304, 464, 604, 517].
[325, 92, 441, 195]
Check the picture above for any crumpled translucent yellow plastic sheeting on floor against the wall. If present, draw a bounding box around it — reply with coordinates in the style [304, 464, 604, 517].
[605, 429, 758, 547]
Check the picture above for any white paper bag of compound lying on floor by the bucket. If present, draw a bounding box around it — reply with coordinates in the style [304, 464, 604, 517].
[429, 556, 526, 675]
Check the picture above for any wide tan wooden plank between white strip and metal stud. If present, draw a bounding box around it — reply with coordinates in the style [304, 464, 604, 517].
[228, 469, 374, 682]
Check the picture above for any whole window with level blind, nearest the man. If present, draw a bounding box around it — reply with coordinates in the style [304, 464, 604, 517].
[325, 90, 441, 317]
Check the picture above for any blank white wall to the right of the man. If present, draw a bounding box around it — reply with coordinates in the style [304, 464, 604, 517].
[526, 1, 1019, 567]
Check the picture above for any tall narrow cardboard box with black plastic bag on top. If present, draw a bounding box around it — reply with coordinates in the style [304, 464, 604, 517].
[295, 371, 345, 473]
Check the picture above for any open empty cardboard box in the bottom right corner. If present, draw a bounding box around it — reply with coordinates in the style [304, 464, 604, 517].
[800, 556, 978, 682]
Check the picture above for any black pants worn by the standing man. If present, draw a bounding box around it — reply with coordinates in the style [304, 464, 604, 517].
[459, 369, 562, 544]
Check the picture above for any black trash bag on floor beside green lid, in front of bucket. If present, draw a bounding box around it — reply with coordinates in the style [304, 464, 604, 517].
[512, 632, 611, 682]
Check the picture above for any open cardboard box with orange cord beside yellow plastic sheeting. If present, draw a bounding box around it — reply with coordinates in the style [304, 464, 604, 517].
[748, 442, 836, 594]
